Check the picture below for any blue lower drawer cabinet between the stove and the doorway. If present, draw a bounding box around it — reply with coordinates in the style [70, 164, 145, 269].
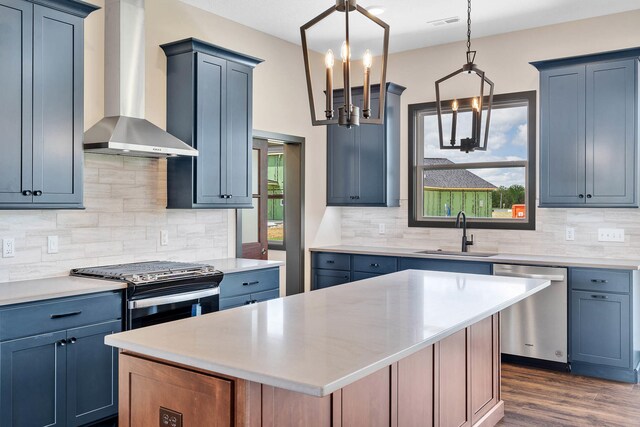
[220, 267, 280, 310]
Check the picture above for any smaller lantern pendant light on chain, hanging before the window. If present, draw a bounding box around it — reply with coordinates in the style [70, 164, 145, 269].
[436, 0, 493, 153]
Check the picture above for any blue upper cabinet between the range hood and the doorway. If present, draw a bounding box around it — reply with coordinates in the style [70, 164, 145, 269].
[161, 38, 262, 209]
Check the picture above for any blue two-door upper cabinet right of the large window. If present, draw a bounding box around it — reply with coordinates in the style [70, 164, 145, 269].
[533, 49, 640, 207]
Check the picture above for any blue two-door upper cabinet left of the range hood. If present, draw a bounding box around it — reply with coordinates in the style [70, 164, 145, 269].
[0, 0, 97, 209]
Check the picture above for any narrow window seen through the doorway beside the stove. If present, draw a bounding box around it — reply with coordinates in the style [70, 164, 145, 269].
[267, 141, 284, 250]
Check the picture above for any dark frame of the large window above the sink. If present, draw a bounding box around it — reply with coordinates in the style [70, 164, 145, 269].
[407, 90, 537, 230]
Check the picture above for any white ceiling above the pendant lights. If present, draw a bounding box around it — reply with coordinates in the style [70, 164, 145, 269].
[180, 0, 640, 52]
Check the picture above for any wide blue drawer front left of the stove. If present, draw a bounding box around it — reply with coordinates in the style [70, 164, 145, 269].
[0, 292, 123, 341]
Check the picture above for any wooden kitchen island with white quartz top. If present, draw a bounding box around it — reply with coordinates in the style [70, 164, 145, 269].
[105, 270, 550, 427]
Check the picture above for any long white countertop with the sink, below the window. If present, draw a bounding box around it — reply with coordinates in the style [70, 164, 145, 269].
[309, 245, 640, 270]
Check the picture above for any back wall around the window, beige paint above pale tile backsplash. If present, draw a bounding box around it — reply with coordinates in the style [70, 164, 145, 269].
[342, 10, 640, 258]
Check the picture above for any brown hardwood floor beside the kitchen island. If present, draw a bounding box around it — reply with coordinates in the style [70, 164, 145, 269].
[498, 363, 640, 427]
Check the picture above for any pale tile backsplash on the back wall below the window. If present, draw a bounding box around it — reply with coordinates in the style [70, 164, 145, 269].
[341, 200, 640, 259]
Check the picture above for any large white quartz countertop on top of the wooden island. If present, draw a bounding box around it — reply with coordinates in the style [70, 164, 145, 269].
[105, 270, 550, 396]
